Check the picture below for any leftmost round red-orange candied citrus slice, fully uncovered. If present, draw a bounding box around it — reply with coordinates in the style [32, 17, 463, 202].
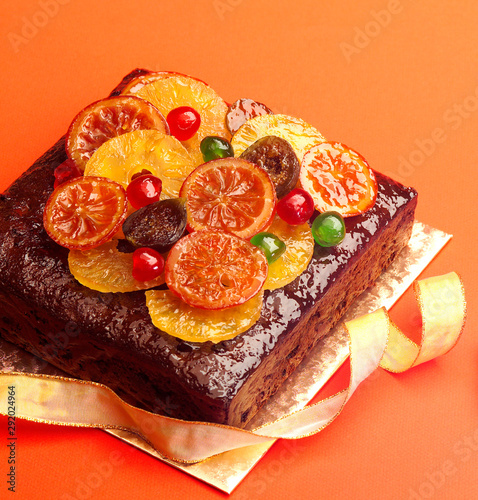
[43, 177, 128, 250]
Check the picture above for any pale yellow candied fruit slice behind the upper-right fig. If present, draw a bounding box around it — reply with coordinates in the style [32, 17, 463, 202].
[231, 115, 325, 162]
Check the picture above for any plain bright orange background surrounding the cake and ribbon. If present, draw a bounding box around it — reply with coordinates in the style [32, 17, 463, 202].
[0, 0, 478, 500]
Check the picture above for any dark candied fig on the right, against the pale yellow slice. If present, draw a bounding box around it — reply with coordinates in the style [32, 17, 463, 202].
[240, 135, 300, 198]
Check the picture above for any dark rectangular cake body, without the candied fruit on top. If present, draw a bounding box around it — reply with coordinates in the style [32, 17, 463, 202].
[0, 73, 417, 427]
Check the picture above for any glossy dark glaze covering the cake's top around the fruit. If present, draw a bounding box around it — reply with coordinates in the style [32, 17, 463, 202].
[0, 70, 416, 424]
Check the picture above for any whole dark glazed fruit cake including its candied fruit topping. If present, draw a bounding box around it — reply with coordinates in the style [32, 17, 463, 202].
[0, 70, 417, 427]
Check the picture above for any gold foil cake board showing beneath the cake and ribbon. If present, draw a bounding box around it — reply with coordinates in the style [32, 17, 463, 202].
[0, 222, 451, 493]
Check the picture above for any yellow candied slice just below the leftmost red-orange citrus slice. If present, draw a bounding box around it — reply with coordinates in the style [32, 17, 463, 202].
[68, 240, 164, 293]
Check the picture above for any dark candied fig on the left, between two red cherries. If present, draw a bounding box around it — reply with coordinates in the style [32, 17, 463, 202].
[123, 198, 187, 253]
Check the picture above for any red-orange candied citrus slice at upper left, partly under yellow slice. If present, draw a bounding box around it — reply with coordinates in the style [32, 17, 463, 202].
[66, 96, 169, 170]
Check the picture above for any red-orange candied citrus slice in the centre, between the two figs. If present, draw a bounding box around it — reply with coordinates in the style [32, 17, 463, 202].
[180, 158, 276, 239]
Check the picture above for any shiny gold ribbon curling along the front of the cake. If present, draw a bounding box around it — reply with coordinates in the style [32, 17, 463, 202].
[0, 273, 466, 463]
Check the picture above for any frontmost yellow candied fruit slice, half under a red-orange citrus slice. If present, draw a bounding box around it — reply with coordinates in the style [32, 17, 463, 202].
[146, 290, 263, 343]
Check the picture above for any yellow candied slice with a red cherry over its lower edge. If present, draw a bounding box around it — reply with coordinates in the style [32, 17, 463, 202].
[85, 130, 195, 199]
